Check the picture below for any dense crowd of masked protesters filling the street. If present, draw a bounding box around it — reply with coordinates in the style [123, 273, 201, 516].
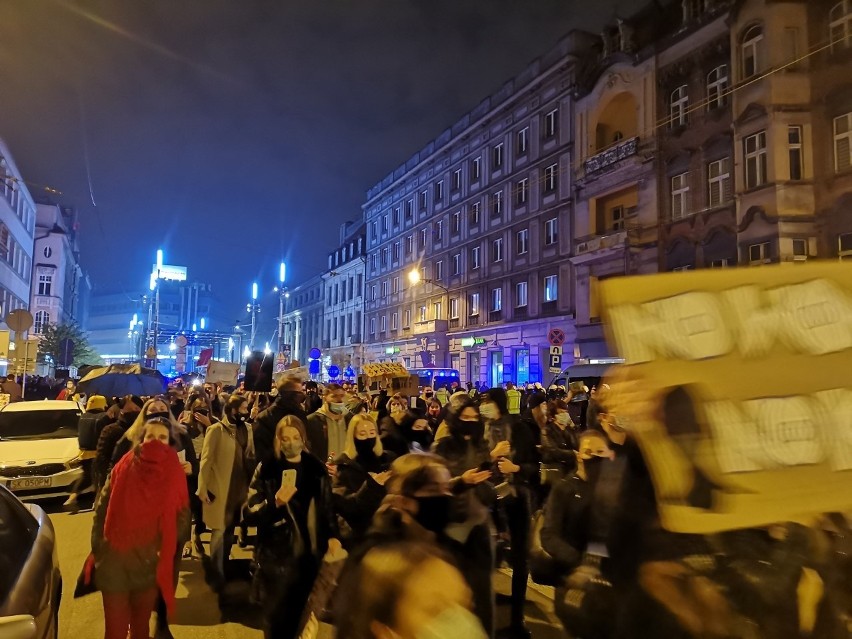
[28, 376, 852, 639]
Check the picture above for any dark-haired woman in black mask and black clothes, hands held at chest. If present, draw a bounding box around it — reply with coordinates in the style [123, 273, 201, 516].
[433, 400, 497, 635]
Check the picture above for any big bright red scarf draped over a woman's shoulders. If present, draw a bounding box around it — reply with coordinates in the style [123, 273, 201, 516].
[104, 441, 189, 612]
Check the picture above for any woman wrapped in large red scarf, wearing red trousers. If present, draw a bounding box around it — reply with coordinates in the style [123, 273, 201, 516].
[92, 417, 189, 639]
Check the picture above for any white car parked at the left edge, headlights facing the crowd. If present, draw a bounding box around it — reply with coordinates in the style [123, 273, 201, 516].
[0, 400, 83, 500]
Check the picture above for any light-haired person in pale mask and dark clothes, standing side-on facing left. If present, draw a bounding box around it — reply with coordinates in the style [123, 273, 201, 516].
[479, 388, 540, 638]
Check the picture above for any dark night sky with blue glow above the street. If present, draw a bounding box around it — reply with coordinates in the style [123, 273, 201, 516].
[0, 0, 638, 328]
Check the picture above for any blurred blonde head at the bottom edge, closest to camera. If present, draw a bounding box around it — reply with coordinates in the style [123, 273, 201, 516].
[337, 542, 486, 639]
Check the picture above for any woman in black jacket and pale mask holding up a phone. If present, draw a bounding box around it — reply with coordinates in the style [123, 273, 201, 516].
[243, 415, 341, 639]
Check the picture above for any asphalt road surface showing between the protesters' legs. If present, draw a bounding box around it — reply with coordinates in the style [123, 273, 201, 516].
[48, 503, 564, 639]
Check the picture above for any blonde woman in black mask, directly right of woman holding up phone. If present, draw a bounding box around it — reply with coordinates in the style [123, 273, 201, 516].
[334, 414, 395, 547]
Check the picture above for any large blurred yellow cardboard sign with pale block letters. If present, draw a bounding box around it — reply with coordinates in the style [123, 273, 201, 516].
[601, 263, 852, 533]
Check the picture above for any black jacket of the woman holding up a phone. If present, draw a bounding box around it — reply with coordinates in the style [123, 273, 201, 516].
[243, 452, 339, 567]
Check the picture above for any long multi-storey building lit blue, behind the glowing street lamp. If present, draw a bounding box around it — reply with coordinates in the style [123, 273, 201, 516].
[363, 33, 588, 385]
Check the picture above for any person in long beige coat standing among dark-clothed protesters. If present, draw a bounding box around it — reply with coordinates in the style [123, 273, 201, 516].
[197, 395, 254, 589]
